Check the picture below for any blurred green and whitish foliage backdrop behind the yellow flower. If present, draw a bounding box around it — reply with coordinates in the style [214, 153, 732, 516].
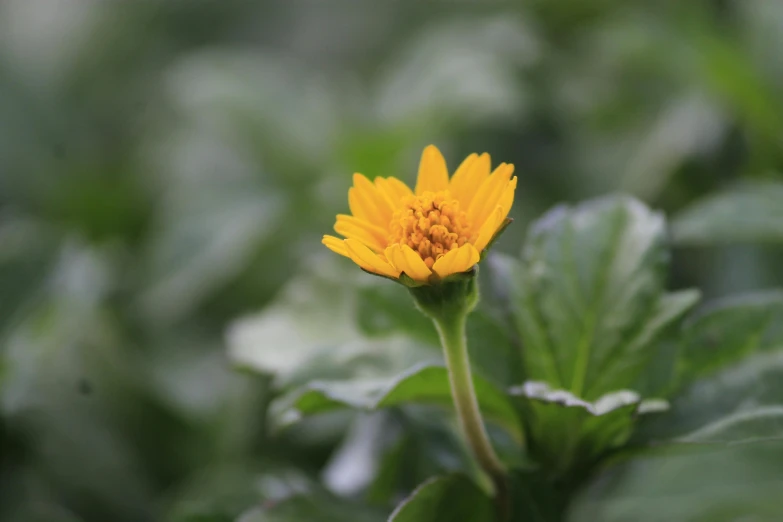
[0, 0, 783, 522]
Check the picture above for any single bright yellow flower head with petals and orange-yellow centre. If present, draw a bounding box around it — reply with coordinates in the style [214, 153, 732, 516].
[323, 145, 517, 284]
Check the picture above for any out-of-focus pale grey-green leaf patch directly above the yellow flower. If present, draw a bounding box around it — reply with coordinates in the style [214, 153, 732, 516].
[375, 13, 539, 132]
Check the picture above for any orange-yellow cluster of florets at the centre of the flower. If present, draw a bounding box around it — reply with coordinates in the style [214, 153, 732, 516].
[389, 190, 476, 268]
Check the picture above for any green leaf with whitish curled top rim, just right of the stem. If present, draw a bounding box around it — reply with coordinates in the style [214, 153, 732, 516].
[509, 381, 668, 472]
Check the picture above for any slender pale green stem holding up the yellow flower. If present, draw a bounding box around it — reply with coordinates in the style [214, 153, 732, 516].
[433, 313, 509, 520]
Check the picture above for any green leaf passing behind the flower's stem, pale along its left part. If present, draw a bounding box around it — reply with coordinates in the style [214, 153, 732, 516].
[274, 365, 523, 441]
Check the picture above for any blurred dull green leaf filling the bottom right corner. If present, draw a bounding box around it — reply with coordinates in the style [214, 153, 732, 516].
[567, 441, 783, 522]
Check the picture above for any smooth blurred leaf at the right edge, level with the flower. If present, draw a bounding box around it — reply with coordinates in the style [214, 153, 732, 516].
[672, 182, 783, 245]
